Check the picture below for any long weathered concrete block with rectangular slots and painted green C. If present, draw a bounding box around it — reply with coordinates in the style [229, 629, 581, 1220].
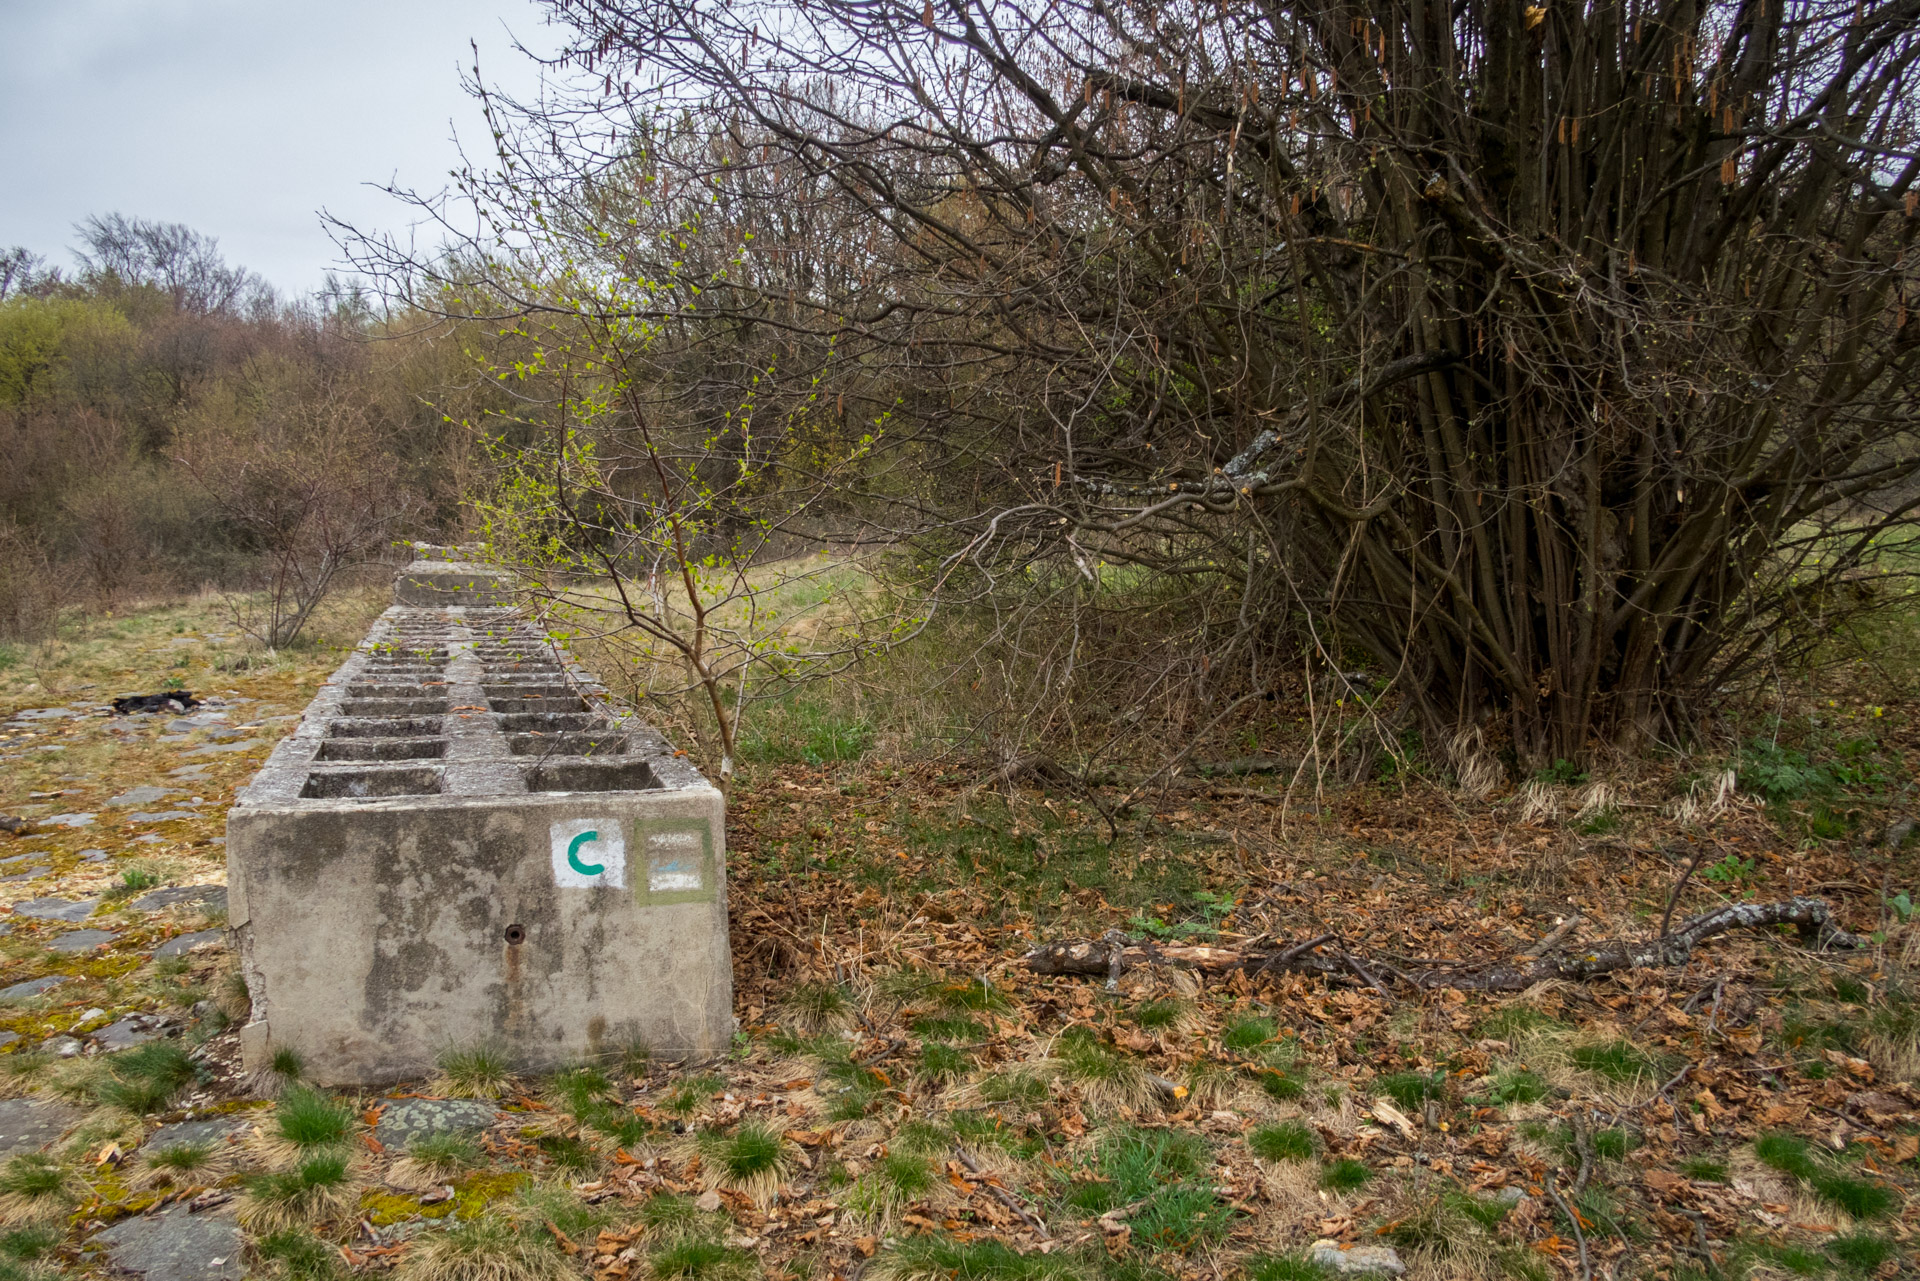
[227, 605, 733, 1085]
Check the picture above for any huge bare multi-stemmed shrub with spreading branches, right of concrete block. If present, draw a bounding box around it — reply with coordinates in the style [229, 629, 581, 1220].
[378, 0, 1920, 762]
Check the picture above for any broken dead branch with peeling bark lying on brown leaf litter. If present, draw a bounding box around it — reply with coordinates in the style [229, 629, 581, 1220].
[1021, 897, 1864, 991]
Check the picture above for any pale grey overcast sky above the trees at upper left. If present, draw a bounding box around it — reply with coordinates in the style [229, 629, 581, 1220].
[0, 0, 553, 292]
